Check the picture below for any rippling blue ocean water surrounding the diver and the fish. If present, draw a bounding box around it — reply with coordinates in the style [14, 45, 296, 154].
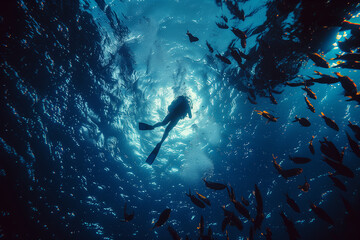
[0, 0, 360, 239]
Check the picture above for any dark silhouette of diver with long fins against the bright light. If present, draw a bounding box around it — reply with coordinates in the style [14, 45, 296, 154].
[139, 96, 192, 165]
